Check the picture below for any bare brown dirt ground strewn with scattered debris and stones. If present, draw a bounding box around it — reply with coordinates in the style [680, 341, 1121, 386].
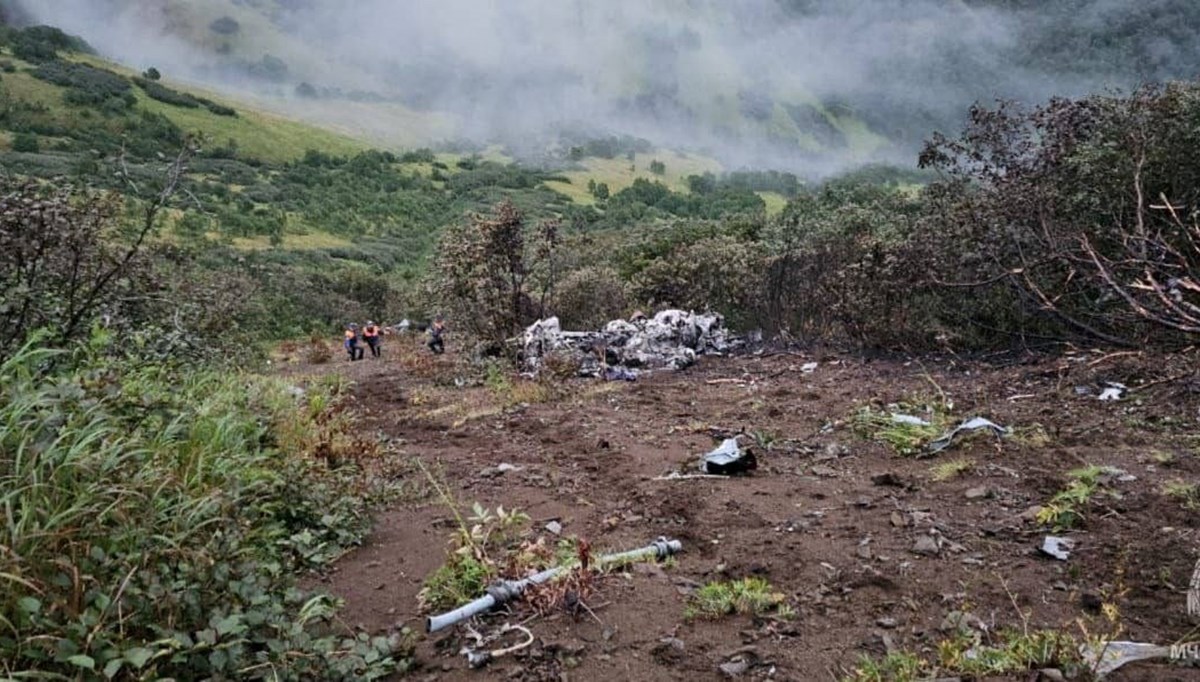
[283, 341, 1200, 681]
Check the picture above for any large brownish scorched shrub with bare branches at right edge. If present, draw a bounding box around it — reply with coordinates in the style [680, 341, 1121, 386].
[922, 84, 1200, 345]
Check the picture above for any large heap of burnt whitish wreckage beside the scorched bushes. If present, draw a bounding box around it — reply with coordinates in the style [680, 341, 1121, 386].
[522, 310, 745, 378]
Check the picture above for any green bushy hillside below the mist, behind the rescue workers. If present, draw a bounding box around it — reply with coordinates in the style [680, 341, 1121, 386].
[0, 22, 799, 335]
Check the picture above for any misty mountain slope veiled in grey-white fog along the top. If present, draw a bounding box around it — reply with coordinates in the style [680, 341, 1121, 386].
[4, 0, 1200, 174]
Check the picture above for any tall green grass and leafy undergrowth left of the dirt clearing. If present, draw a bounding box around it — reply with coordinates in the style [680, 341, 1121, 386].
[0, 345, 400, 680]
